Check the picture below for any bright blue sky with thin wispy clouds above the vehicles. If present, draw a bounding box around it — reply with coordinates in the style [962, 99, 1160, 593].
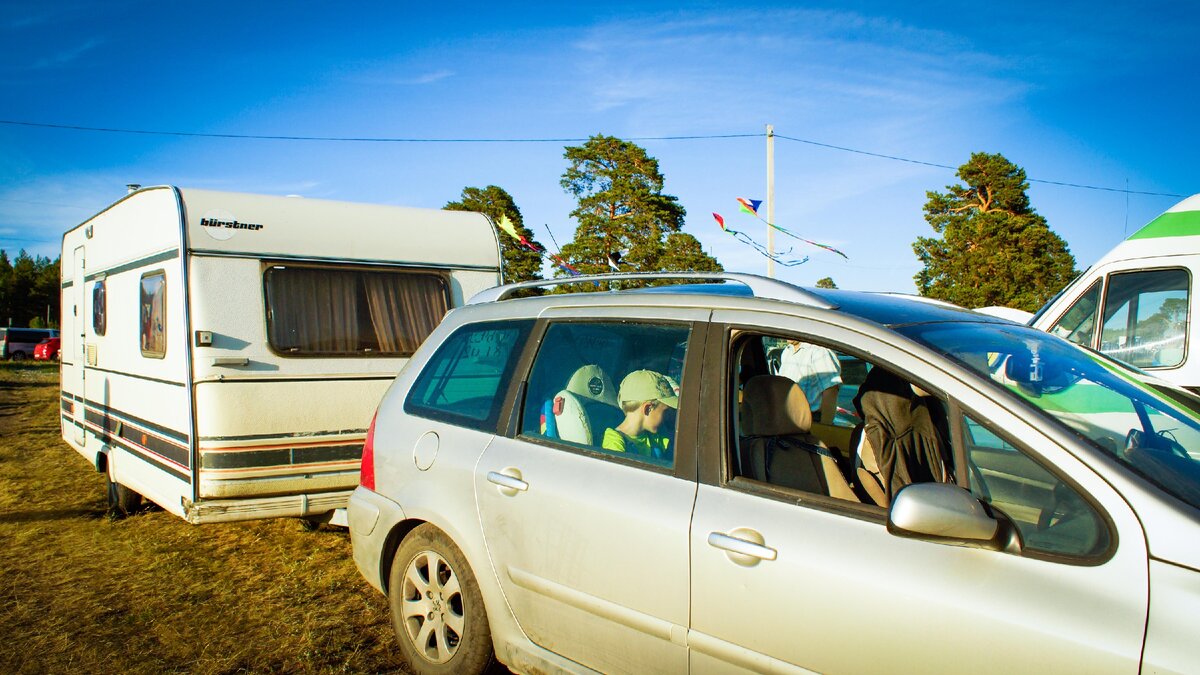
[0, 0, 1200, 292]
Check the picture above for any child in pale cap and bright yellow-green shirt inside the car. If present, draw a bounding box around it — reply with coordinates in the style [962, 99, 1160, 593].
[601, 370, 679, 459]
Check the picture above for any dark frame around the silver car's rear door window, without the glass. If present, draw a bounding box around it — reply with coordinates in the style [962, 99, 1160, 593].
[500, 316, 708, 480]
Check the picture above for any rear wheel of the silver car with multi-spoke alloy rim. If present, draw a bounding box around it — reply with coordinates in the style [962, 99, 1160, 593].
[388, 524, 494, 675]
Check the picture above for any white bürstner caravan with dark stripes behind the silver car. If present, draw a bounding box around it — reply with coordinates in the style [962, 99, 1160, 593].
[61, 186, 500, 522]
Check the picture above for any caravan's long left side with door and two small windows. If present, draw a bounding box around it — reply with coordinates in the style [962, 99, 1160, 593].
[62, 189, 192, 514]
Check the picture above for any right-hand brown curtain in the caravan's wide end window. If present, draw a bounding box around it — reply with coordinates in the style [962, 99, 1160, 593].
[362, 273, 448, 354]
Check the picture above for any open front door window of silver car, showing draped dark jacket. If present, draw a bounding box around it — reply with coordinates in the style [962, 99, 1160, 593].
[728, 333, 954, 507]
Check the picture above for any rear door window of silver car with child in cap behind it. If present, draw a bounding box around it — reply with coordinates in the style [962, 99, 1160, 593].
[521, 322, 690, 467]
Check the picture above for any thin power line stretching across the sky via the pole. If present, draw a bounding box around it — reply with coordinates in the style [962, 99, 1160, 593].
[0, 120, 1186, 198]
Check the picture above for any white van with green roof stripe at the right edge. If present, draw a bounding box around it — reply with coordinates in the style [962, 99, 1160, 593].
[1030, 195, 1200, 392]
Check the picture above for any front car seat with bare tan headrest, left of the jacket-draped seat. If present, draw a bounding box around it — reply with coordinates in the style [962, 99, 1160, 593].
[738, 375, 859, 502]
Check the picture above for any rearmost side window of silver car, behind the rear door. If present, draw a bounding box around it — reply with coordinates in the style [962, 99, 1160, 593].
[404, 321, 533, 431]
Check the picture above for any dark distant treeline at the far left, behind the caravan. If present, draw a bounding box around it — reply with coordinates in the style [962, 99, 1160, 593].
[0, 249, 60, 328]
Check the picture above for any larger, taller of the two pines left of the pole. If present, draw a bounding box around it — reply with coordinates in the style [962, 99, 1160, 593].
[557, 136, 722, 284]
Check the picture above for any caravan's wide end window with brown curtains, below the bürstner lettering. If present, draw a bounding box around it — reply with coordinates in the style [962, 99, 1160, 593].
[263, 265, 450, 357]
